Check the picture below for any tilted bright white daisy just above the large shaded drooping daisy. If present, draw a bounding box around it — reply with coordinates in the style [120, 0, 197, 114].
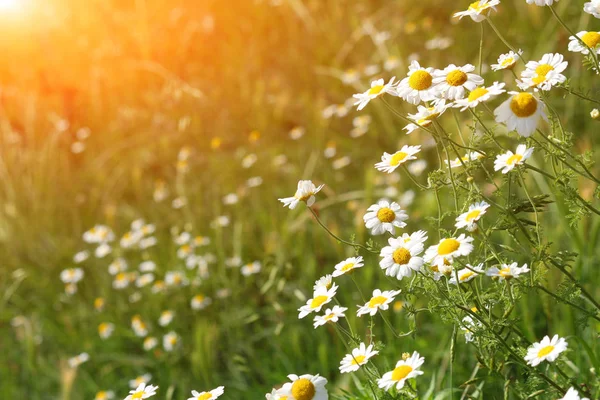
[517, 53, 569, 90]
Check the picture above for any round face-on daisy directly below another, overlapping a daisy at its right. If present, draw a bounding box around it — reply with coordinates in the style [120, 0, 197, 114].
[379, 237, 424, 280]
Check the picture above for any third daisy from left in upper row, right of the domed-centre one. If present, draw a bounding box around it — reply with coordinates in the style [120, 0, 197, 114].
[433, 64, 483, 100]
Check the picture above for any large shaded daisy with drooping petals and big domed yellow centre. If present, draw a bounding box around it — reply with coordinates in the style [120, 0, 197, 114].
[494, 92, 548, 137]
